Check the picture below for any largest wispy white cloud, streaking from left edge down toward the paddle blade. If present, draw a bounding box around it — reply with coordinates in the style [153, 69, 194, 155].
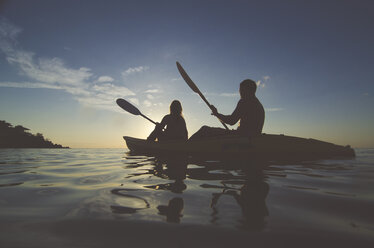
[0, 19, 137, 111]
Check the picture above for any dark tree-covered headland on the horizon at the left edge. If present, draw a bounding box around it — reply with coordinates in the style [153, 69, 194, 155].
[0, 120, 69, 148]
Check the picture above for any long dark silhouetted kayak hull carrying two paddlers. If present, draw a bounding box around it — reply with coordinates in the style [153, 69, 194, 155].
[123, 134, 355, 160]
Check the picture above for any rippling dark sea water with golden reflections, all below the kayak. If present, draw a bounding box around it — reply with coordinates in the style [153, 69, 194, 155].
[0, 149, 374, 247]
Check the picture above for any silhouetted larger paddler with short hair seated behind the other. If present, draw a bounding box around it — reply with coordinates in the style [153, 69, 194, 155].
[190, 79, 265, 139]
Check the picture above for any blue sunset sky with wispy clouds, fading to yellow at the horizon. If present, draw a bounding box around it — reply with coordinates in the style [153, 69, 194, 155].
[0, 0, 374, 148]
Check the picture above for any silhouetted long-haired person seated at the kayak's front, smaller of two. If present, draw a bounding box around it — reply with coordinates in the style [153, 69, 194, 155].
[147, 100, 188, 141]
